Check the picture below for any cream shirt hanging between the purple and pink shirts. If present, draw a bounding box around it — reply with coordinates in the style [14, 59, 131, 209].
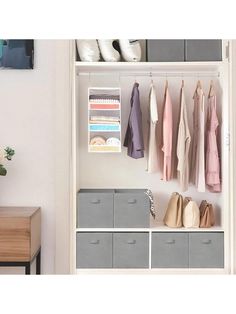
[147, 84, 158, 173]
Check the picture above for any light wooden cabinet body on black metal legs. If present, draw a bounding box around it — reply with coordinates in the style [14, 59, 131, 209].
[0, 207, 41, 274]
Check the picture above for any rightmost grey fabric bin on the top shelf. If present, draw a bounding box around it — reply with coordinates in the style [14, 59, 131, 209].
[185, 39, 222, 61]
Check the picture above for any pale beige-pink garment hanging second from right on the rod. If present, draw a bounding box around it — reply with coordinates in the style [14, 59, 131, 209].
[191, 87, 205, 192]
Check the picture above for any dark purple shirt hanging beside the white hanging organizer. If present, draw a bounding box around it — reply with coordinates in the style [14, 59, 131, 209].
[124, 83, 144, 159]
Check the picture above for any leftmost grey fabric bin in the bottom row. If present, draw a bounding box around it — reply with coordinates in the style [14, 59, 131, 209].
[76, 232, 112, 268]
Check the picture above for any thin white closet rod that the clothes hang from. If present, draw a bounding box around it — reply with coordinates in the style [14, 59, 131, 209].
[77, 71, 220, 78]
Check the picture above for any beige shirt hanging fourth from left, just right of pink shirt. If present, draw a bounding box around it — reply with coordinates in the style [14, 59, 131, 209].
[177, 87, 191, 192]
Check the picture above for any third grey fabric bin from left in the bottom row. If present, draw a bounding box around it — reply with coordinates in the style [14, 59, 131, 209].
[152, 232, 189, 268]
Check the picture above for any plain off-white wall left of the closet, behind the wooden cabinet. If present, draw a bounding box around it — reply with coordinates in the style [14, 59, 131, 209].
[0, 40, 69, 274]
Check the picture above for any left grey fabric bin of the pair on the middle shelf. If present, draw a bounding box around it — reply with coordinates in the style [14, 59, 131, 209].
[77, 189, 114, 228]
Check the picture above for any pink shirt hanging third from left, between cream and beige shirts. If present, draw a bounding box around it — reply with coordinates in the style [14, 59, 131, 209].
[162, 87, 173, 181]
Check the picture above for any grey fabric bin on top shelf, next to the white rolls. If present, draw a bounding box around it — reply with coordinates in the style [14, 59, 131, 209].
[147, 39, 184, 62]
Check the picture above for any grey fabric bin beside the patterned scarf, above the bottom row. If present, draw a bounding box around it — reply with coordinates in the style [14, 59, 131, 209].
[114, 189, 150, 228]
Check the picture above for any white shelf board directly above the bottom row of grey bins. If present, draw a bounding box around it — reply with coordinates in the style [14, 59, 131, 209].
[76, 225, 224, 232]
